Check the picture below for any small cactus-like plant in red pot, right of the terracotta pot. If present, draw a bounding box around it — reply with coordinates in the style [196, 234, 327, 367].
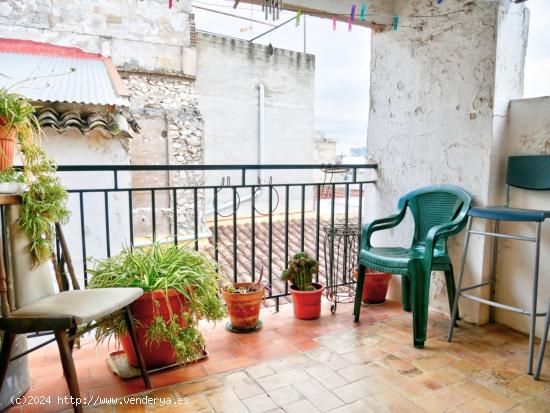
[281, 252, 324, 320]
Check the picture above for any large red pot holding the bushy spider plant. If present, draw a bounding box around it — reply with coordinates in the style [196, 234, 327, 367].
[120, 290, 189, 369]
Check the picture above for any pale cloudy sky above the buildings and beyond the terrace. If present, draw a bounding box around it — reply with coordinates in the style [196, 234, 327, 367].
[192, 0, 550, 152]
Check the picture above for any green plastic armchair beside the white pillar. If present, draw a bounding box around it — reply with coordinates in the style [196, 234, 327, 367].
[353, 185, 472, 348]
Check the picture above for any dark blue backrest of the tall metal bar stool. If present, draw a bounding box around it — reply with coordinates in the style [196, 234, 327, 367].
[506, 155, 550, 190]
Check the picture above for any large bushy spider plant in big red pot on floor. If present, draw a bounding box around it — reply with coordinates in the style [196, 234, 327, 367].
[88, 243, 225, 369]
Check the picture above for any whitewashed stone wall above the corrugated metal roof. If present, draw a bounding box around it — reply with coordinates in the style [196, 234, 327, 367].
[0, 0, 193, 74]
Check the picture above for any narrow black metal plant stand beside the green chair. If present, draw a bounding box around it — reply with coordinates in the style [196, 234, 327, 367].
[324, 224, 361, 314]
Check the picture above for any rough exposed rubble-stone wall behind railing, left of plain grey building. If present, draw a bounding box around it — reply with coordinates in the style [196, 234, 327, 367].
[123, 72, 204, 237]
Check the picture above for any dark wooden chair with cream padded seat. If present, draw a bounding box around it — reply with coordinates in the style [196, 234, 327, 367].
[0, 196, 152, 412]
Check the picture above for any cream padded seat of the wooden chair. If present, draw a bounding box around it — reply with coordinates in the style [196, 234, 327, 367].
[10, 288, 143, 324]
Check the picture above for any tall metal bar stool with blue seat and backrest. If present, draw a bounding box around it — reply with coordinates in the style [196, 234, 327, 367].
[447, 155, 550, 374]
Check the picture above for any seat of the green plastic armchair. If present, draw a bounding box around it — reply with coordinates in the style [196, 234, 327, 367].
[359, 247, 448, 269]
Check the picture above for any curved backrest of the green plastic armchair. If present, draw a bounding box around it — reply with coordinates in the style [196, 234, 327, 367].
[399, 185, 472, 251]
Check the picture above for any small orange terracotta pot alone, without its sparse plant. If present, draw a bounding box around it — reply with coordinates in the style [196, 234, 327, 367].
[223, 283, 265, 330]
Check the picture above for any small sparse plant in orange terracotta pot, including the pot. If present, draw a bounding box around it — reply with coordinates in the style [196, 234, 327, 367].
[223, 268, 266, 333]
